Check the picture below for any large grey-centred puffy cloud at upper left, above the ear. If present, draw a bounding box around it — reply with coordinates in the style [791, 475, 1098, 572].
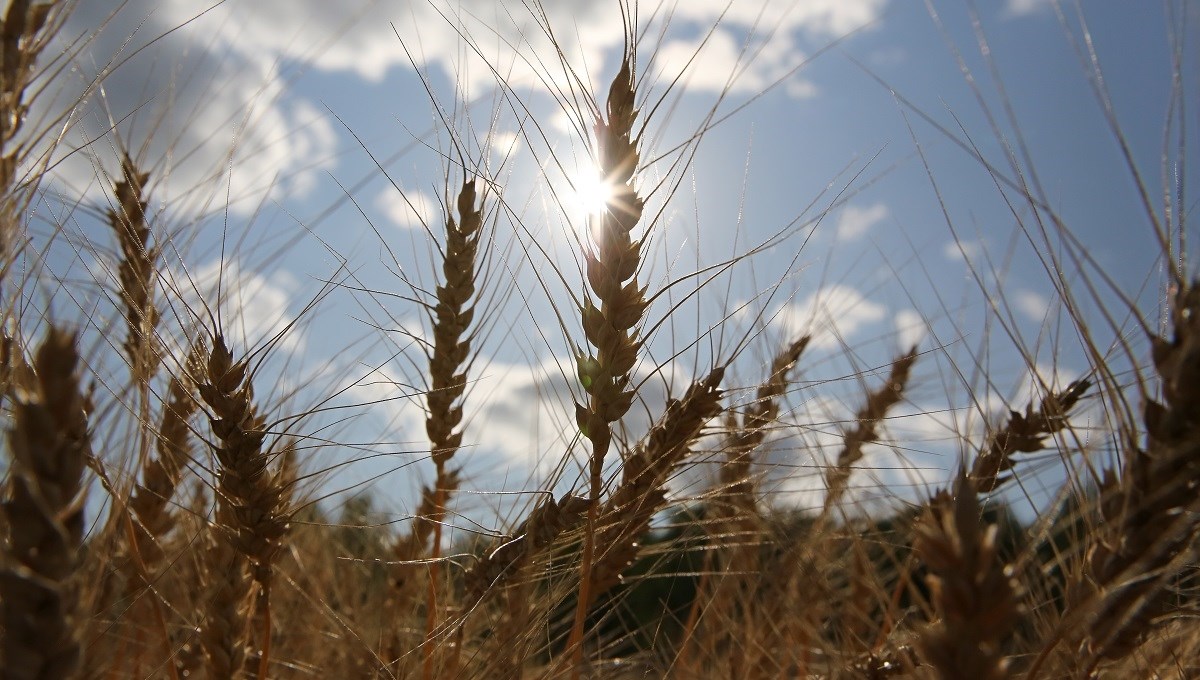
[45, 2, 337, 215]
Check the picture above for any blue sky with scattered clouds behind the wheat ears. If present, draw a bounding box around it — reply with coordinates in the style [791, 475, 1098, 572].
[42, 0, 1200, 525]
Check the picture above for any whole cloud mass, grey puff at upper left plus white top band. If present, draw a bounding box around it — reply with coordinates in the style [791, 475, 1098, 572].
[42, 0, 886, 215]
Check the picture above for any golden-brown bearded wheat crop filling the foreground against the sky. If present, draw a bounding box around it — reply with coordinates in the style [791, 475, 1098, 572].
[0, 0, 1200, 680]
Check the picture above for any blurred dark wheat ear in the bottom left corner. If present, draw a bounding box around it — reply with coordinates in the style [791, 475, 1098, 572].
[0, 326, 91, 680]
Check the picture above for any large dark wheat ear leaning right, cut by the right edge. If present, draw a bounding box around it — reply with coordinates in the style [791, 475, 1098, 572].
[1063, 279, 1200, 670]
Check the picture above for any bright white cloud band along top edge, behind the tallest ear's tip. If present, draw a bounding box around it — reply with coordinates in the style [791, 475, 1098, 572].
[140, 0, 887, 98]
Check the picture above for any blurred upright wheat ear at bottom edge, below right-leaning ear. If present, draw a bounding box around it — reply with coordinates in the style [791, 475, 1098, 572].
[913, 474, 1018, 680]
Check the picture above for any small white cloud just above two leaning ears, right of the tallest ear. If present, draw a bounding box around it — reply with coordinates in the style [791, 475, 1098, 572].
[774, 284, 887, 348]
